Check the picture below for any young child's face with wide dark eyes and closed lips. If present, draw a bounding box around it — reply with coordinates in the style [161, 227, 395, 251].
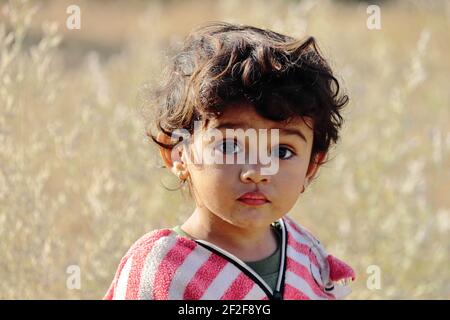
[181, 104, 324, 228]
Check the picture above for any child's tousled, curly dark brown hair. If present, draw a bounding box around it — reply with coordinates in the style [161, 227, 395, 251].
[147, 22, 348, 164]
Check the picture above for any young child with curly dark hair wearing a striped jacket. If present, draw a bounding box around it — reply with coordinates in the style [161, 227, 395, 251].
[104, 22, 355, 300]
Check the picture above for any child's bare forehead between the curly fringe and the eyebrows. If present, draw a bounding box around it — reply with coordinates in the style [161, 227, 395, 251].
[207, 103, 313, 141]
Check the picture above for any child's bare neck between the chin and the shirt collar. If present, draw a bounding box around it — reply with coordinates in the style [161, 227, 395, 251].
[181, 208, 277, 262]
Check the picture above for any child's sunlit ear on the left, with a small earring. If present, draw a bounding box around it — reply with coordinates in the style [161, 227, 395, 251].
[156, 132, 187, 179]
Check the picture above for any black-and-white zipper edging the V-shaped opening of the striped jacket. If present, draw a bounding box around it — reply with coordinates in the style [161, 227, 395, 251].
[195, 218, 287, 300]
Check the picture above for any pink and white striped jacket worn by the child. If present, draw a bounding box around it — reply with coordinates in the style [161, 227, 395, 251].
[103, 216, 355, 300]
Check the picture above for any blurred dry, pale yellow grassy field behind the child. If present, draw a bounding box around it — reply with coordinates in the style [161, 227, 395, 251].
[0, 0, 450, 299]
